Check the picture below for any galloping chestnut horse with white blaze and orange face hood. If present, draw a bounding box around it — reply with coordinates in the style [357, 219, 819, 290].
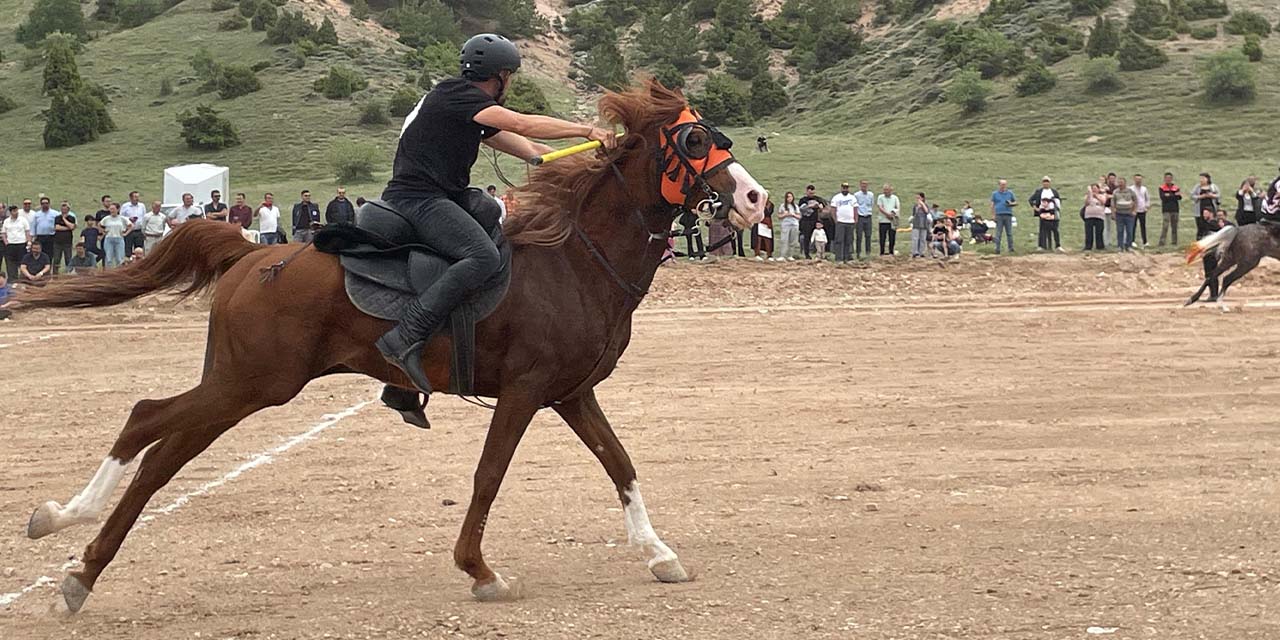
[19, 79, 768, 612]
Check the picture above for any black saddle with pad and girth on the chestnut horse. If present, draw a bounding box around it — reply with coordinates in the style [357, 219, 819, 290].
[314, 189, 511, 396]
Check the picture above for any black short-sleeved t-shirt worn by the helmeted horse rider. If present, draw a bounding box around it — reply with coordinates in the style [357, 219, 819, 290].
[383, 78, 498, 198]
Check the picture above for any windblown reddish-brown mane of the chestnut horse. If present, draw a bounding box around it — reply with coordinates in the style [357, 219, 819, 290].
[503, 77, 689, 247]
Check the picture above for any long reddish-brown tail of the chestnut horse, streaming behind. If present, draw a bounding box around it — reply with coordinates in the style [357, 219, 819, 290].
[14, 220, 266, 308]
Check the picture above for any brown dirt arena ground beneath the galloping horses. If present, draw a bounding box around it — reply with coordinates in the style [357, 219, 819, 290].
[0, 256, 1280, 639]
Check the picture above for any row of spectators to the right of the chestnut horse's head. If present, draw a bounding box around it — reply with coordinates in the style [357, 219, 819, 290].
[672, 168, 1280, 265]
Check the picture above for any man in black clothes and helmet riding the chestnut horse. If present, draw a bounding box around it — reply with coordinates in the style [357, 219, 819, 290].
[376, 33, 617, 393]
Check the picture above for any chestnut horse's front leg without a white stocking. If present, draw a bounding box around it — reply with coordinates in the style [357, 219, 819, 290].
[453, 396, 539, 602]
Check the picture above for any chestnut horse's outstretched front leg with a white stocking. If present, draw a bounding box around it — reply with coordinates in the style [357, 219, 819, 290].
[553, 390, 689, 582]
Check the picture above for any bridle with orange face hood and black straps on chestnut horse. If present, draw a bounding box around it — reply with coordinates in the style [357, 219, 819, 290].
[573, 108, 733, 305]
